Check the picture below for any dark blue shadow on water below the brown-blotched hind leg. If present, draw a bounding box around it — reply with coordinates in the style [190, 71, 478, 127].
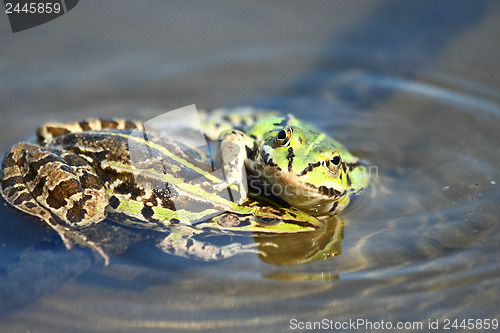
[0, 199, 92, 315]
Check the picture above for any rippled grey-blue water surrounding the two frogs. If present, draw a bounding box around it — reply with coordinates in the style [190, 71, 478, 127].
[0, 1, 500, 332]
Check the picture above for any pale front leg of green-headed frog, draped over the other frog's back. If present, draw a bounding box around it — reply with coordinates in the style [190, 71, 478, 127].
[217, 130, 254, 204]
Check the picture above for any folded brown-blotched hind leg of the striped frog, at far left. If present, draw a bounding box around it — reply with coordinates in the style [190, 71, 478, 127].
[0, 143, 108, 263]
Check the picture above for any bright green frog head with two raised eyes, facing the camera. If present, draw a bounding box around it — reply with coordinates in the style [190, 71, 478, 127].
[245, 116, 357, 216]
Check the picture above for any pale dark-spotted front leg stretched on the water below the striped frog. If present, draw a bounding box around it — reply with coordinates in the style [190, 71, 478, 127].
[157, 226, 274, 261]
